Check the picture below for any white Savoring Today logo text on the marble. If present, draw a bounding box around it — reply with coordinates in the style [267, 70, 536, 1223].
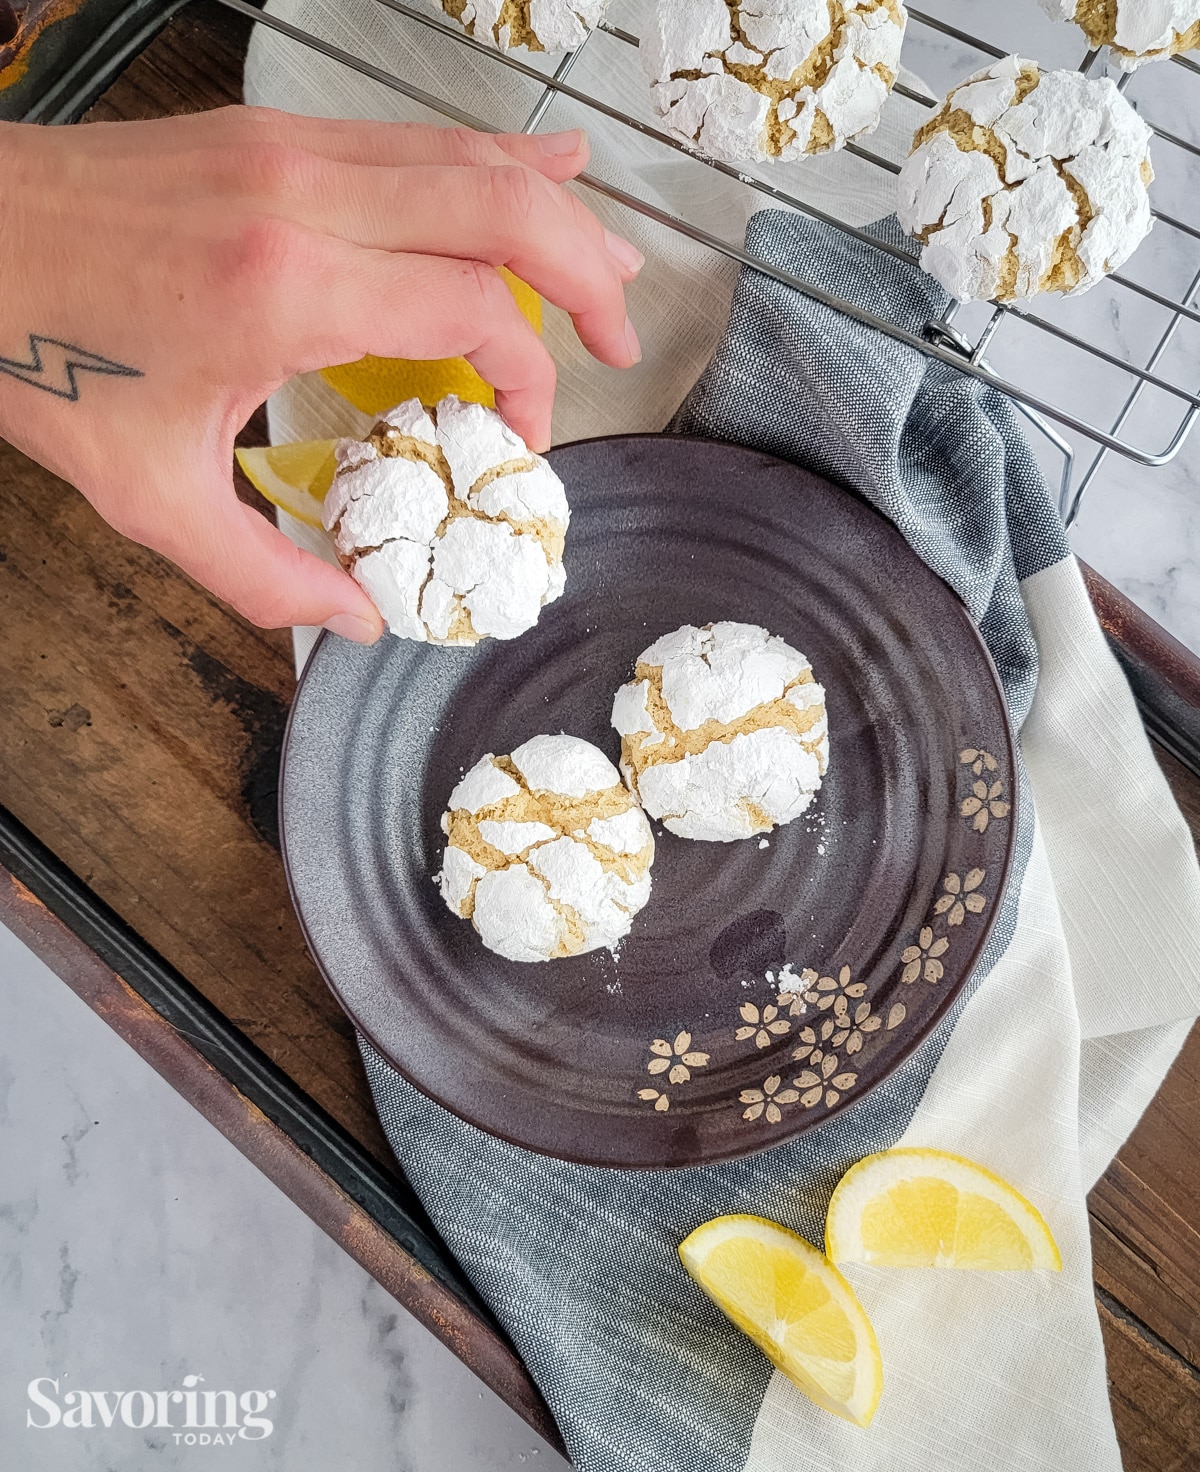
[25, 1375, 275, 1447]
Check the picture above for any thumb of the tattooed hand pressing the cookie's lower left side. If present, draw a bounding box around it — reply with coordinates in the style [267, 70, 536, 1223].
[159, 486, 383, 643]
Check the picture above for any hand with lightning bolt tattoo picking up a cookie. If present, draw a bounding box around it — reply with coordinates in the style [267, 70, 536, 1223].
[0, 107, 640, 643]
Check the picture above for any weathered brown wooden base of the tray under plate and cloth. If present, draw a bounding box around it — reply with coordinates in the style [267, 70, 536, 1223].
[0, 0, 1200, 1472]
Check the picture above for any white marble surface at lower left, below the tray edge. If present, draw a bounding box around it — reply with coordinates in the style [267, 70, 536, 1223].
[0, 927, 565, 1472]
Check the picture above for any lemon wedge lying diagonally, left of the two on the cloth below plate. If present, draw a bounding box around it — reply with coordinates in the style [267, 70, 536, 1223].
[679, 1216, 883, 1426]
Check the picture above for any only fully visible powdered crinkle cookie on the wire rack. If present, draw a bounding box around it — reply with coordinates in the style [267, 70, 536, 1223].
[897, 56, 1154, 302]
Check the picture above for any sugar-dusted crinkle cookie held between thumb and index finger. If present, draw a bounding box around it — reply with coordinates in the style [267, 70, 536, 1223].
[324, 396, 570, 645]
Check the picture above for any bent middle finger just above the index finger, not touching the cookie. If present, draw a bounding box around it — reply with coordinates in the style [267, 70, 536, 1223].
[278, 160, 642, 368]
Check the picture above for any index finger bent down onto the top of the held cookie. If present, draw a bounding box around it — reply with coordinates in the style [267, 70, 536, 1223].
[285, 241, 555, 450]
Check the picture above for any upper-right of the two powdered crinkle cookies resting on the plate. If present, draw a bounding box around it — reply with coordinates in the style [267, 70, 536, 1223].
[613, 623, 829, 842]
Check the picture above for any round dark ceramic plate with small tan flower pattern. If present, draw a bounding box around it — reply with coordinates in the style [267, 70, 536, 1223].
[281, 437, 1014, 1166]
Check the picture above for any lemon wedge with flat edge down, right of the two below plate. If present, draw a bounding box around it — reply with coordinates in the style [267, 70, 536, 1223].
[825, 1150, 1063, 1272]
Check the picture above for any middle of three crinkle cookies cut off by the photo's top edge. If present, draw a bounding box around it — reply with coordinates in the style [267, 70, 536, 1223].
[640, 0, 907, 163]
